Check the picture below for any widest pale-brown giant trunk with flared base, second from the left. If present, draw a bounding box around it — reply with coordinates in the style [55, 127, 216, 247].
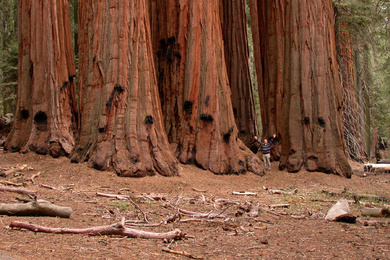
[72, 0, 178, 176]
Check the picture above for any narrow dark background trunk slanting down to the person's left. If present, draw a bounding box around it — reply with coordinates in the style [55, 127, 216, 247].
[221, 0, 258, 148]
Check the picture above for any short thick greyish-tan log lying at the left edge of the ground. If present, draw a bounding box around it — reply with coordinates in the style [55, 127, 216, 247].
[0, 200, 73, 218]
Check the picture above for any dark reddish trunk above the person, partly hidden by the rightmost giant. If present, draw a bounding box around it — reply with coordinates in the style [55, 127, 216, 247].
[249, 0, 286, 160]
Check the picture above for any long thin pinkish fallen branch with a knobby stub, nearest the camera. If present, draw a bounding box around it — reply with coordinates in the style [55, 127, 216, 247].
[9, 220, 185, 239]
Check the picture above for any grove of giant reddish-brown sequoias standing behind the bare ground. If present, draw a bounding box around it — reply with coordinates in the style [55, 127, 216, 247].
[0, 0, 390, 177]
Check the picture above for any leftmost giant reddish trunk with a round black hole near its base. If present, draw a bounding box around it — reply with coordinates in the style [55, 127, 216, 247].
[5, 0, 77, 157]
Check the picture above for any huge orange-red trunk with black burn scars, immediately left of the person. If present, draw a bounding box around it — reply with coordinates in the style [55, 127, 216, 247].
[150, 0, 263, 174]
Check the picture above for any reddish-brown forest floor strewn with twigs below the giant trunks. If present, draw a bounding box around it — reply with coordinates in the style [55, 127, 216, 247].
[0, 151, 390, 259]
